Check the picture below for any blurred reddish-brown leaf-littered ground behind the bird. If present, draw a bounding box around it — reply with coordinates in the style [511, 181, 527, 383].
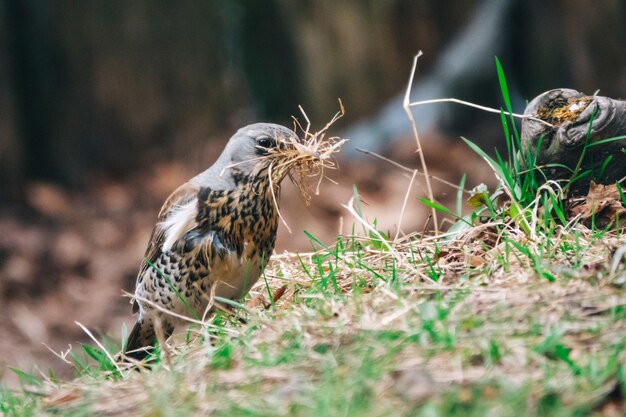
[0, 137, 493, 385]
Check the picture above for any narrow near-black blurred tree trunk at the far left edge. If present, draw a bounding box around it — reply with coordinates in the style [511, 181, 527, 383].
[5, 0, 72, 185]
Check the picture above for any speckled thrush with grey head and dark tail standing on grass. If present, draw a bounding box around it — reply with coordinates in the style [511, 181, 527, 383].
[124, 123, 305, 360]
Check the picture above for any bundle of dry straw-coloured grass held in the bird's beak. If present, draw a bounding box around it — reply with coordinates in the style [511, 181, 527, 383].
[270, 100, 347, 205]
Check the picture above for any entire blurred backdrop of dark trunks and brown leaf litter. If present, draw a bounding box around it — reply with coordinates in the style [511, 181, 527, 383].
[0, 0, 626, 384]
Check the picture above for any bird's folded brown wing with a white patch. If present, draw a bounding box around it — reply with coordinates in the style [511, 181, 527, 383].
[133, 182, 200, 313]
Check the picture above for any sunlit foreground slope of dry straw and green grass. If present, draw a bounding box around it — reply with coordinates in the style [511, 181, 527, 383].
[7, 221, 626, 416]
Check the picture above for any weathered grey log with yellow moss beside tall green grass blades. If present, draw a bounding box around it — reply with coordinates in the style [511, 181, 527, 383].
[521, 88, 626, 190]
